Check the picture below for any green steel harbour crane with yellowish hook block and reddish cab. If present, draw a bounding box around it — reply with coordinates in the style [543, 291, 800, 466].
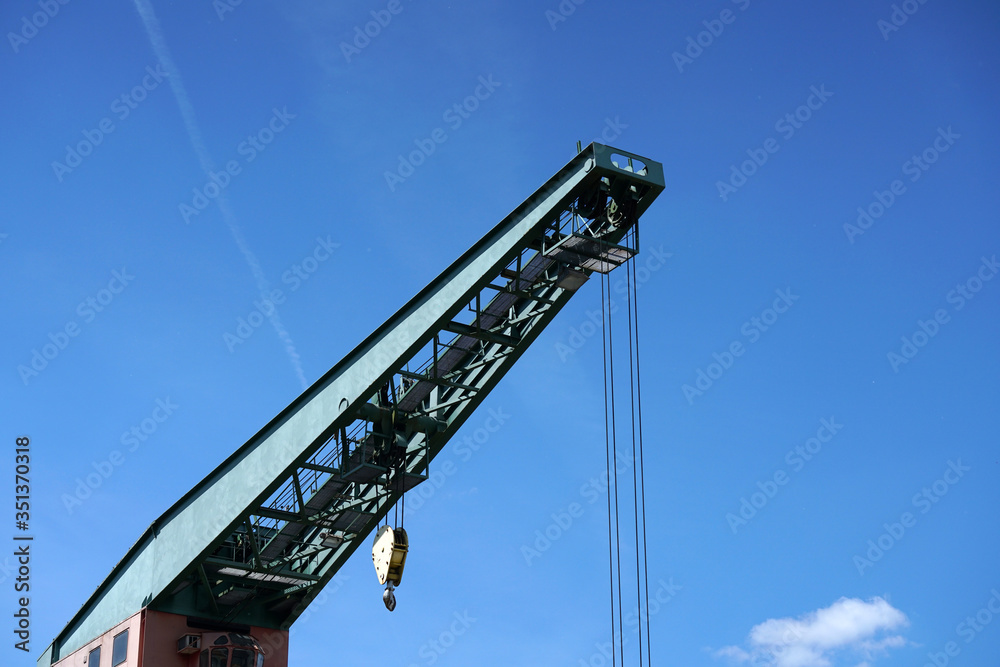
[38, 143, 664, 667]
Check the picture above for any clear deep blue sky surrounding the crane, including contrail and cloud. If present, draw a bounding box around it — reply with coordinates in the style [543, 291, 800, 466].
[0, 0, 1000, 667]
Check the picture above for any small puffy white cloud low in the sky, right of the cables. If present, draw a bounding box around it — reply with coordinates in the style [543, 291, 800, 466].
[715, 597, 909, 667]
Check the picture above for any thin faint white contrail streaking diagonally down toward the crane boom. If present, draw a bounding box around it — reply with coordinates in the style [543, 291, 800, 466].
[135, 0, 309, 389]
